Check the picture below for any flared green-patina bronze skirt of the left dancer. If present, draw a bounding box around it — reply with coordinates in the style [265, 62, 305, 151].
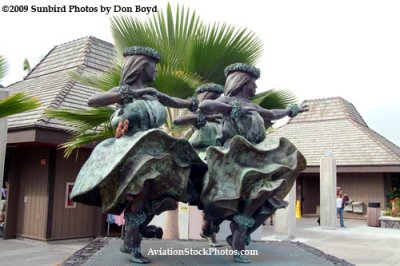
[71, 129, 207, 215]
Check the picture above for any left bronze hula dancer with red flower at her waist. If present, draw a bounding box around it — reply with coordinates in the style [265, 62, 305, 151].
[71, 46, 206, 263]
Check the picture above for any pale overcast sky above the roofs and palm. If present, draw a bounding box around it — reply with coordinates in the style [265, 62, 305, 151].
[0, 0, 400, 146]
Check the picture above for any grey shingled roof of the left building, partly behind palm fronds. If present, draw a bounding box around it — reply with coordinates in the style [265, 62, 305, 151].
[7, 37, 116, 131]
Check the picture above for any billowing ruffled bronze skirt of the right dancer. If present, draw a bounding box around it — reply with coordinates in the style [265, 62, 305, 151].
[201, 136, 306, 219]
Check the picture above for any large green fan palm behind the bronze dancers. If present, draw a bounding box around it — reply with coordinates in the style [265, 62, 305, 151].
[47, 5, 295, 156]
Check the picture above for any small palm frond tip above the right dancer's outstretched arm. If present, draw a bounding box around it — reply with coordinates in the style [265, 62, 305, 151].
[251, 89, 296, 109]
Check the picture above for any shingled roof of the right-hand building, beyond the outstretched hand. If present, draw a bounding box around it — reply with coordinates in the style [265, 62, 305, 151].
[271, 97, 400, 167]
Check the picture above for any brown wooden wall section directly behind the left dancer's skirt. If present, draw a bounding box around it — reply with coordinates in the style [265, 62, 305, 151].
[50, 150, 102, 239]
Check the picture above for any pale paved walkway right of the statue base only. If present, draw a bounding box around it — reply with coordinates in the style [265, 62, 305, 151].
[263, 218, 400, 265]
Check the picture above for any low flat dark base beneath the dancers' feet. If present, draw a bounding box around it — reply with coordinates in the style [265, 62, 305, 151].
[62, 238, 352, 266]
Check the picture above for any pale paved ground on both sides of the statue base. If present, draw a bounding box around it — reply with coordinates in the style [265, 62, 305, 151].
[0, 218, 400, 266]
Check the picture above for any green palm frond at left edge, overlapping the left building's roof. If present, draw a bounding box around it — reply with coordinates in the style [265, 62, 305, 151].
[0, 92, 40, 118]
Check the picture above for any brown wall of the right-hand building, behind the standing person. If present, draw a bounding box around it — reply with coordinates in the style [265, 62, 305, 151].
[337, 173, 385, 219]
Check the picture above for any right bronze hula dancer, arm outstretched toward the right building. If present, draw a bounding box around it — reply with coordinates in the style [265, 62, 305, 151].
[199, 63, 307, 263]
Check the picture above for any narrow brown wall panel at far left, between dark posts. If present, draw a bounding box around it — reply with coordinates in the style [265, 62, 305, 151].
[15, 148, 49, 239]
